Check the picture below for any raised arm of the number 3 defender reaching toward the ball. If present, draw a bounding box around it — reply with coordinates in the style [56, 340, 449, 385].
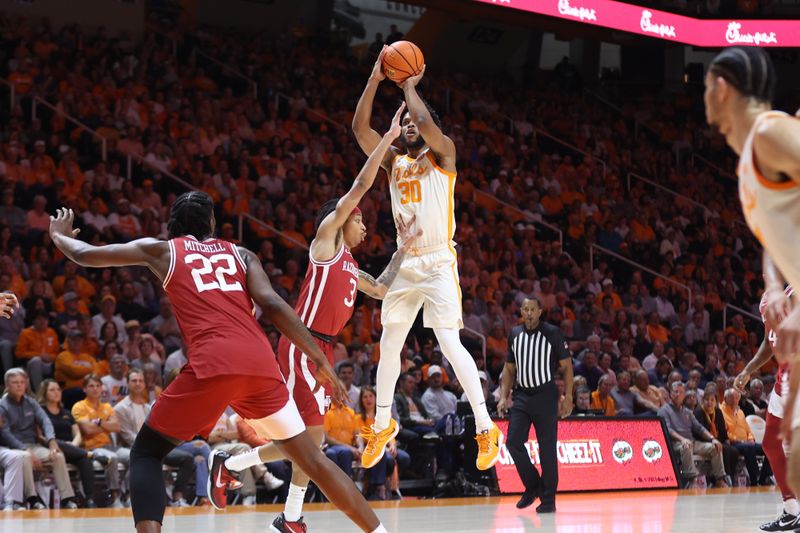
[311, 103, 406, 255]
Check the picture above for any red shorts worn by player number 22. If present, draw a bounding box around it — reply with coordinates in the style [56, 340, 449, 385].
[147, 364, 291, 441]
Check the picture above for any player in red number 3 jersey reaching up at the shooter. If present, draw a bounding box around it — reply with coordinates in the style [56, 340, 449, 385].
[217, 104, 421, 533]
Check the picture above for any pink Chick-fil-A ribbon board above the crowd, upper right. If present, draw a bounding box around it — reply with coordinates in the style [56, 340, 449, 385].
[475, 0, 800, 48]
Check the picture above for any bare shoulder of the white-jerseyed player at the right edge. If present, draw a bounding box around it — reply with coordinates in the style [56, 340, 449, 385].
[753, 117, 800, 183]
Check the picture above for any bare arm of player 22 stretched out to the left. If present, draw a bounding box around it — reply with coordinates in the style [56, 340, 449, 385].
[50, 208, 169, 280]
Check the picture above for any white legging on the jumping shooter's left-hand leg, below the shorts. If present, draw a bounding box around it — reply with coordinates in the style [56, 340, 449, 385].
[375, 324, 411, 431]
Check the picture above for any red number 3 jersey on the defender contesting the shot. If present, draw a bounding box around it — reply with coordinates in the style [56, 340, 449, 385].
[295, 243, 358, 337]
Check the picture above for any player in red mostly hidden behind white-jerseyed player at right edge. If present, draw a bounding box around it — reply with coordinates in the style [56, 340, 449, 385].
[733, 286, 800, 531]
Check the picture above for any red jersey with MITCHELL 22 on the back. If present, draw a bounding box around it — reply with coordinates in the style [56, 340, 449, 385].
[164, 236, 281, 379]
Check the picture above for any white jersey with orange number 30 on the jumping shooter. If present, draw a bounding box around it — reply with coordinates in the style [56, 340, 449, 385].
[389, 148, 456, 249]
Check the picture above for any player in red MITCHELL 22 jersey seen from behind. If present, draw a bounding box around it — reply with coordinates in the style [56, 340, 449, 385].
[50, 198, 386, 533]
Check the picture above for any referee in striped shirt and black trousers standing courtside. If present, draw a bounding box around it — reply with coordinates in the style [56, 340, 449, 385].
[497, 298, 572, 513]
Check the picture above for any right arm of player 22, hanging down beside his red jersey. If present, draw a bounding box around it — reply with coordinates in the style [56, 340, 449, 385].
[239, 246, 348, 405]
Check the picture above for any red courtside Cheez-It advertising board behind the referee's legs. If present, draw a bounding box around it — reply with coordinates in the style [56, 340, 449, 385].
[495, 417, 678, 493]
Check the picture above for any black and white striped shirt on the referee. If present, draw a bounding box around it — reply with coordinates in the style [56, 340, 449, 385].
[508, 322, 571, 389]
